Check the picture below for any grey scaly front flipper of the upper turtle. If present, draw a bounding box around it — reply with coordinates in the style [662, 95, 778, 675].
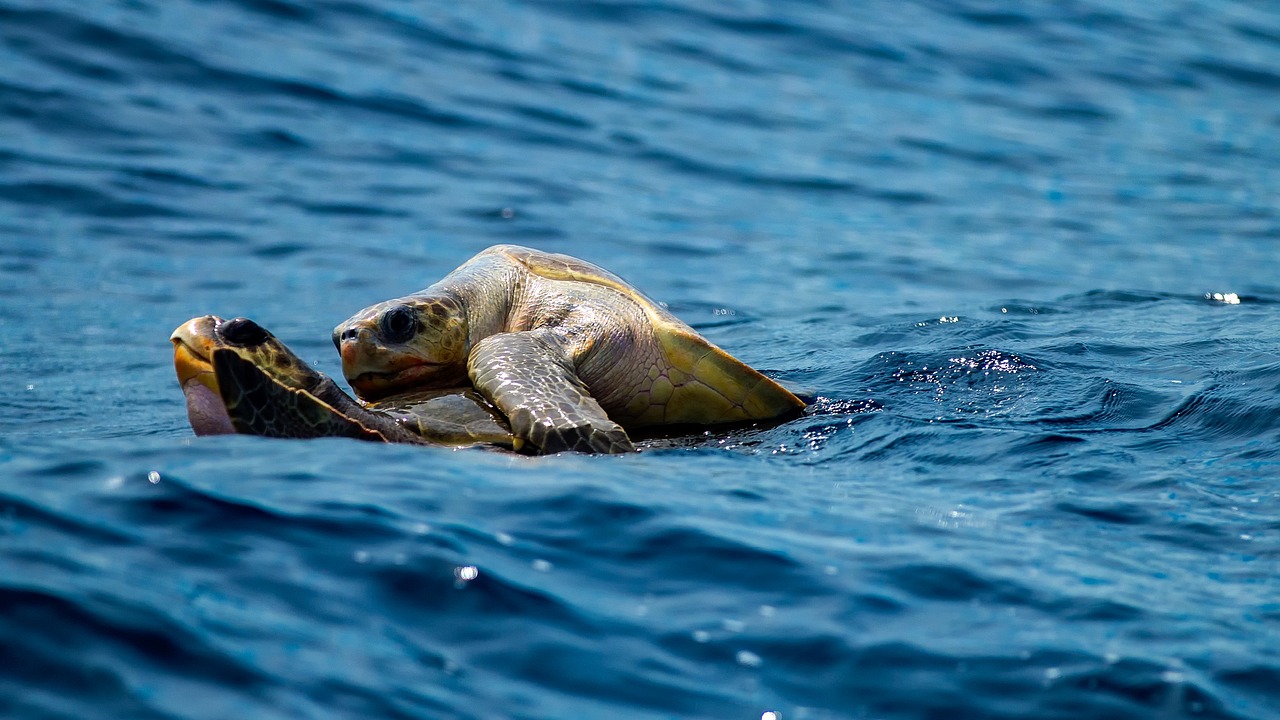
[467, 331, 635, 454]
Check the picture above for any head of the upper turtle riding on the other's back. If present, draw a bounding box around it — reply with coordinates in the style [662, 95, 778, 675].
[333, 293, 471, 400]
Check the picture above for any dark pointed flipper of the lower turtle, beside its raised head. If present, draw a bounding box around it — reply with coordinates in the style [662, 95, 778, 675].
[211, 350, 412, 442]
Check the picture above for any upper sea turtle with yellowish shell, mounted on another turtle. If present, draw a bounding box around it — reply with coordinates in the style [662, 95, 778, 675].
[333, 245, 804, 452]
